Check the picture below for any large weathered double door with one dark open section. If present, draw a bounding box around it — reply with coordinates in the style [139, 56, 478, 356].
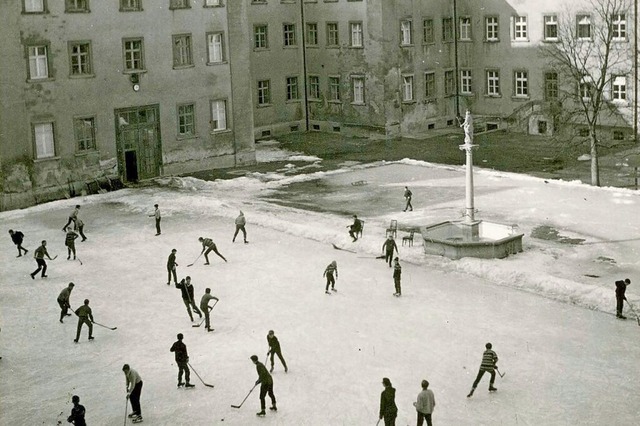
[115, 105, 162, 182]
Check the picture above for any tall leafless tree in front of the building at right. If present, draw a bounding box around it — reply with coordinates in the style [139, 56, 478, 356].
[540, 0, 635, 186]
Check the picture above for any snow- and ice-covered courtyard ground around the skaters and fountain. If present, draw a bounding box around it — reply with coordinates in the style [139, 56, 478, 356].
[0, 149, 640, 426]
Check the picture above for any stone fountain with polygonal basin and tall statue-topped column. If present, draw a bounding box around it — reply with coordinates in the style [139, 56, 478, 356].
[420, 110, 524, 259]
